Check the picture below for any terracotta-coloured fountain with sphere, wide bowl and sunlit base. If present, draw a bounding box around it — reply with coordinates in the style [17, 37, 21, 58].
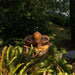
[24, 31, 52, 56]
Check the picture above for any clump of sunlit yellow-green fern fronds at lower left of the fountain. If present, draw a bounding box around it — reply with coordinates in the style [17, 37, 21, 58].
[5, 45, 39, 75]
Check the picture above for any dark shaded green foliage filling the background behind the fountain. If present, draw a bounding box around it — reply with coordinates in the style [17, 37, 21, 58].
[0, 0, 69, 45]
